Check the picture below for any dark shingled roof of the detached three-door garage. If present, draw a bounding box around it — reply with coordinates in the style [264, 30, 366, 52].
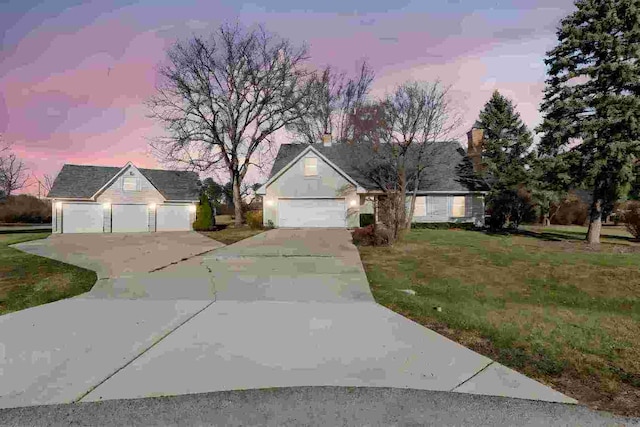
[47, 164, 199, 200]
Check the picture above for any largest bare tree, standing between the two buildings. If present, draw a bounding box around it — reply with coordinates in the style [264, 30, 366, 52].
[148, 25, 311, 226]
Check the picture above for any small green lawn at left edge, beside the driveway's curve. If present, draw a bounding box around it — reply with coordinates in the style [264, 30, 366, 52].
[0, 233, 96, 315]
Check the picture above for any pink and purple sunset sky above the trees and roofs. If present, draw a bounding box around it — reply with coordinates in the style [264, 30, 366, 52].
[0, 0, 574, 192]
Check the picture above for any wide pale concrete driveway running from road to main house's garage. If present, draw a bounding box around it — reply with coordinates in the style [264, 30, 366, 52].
[0, 230, 575, 408]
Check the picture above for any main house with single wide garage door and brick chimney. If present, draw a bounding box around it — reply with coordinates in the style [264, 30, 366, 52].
[257, 133, 487, 228]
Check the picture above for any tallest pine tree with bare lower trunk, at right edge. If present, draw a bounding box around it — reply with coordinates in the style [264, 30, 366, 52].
[537, 0, 640, 243]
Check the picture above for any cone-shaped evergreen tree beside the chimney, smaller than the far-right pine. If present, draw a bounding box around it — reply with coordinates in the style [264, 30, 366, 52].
[475, 90, 533, 228]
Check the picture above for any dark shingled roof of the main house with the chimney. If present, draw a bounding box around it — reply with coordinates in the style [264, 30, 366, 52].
[269, 141, 487, 192]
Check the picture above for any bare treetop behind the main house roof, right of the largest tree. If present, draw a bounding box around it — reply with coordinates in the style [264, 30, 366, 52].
[287, 61, 374, 144]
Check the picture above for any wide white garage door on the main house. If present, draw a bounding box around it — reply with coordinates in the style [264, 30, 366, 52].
[278, 199, 346, 227]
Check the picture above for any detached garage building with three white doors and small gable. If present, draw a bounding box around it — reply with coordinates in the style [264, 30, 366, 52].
[47, 162, 199, 233]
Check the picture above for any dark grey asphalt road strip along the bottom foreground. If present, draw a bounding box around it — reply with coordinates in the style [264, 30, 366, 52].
[0, 387, 640, 426]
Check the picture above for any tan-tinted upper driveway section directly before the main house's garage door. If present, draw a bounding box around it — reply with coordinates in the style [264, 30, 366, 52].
[202, 229, 373, 303]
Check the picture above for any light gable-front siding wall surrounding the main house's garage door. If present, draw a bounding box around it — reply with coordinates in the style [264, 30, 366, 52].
[263, 152, 360, 227]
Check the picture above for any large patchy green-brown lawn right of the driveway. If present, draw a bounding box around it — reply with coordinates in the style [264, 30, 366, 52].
[360, 229, 640, 416]
